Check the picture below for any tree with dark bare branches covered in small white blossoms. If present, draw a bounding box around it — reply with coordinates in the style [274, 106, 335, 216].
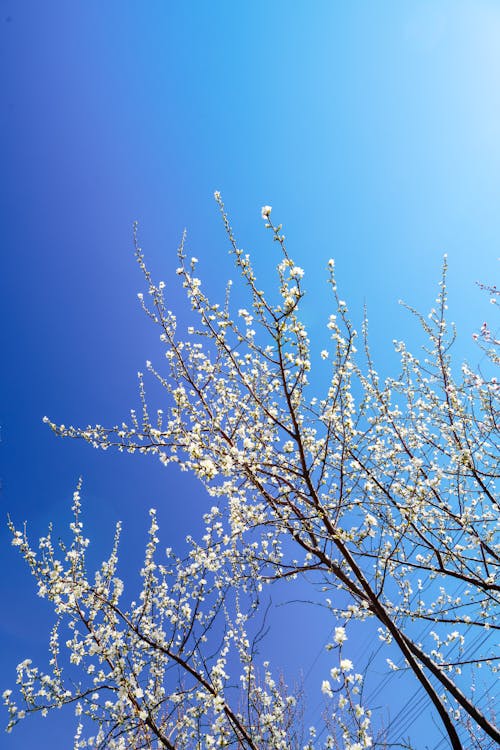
[6, 193, 500, 750]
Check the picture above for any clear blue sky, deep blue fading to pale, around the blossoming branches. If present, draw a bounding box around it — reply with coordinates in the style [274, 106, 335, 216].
[0, 0, 500, 750]
